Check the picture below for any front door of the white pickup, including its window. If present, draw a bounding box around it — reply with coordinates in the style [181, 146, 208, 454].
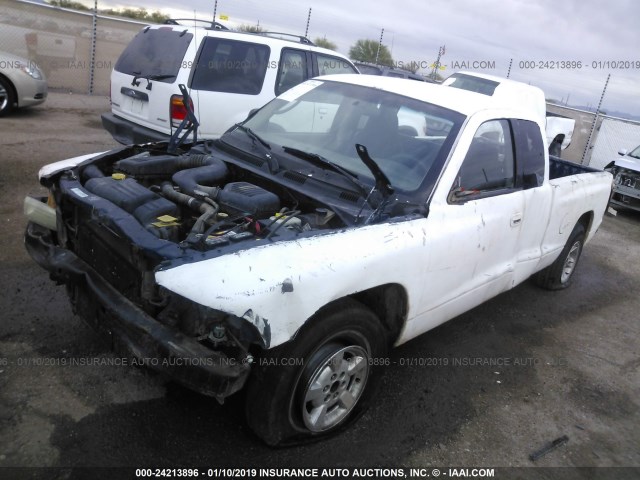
[421, 119, 525, 323]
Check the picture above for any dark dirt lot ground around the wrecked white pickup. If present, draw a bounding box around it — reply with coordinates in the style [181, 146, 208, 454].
[0, 94, 640, 478]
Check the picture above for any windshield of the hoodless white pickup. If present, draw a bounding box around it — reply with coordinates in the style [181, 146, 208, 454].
[235, 80, 464, 193]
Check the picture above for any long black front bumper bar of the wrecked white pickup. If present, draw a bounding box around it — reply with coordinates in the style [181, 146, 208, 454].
[25, 222, 250, 400]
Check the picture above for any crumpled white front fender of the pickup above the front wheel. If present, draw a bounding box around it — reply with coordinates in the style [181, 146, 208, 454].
[156, 219, 426, 347]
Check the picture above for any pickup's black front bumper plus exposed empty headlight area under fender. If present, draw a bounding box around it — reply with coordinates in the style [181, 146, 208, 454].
[25, 222, 264, 401]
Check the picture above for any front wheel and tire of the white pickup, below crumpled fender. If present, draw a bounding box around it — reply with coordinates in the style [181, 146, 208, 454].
[245, 299, 387, 446]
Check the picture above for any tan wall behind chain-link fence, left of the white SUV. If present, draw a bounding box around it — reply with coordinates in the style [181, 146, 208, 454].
[0, 0, 145, 95]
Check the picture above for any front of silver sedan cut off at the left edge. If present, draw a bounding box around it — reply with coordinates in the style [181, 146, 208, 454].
[0, 52, 47, 117]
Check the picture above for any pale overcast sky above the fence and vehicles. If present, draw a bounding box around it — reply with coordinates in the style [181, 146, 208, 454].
[99, 0, 640, 117]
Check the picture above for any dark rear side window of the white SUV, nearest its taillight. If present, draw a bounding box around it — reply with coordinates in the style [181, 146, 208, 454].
[191, 37, 270, 95]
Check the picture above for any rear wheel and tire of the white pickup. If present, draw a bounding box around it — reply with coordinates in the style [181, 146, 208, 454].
[534, 223, 585, 290]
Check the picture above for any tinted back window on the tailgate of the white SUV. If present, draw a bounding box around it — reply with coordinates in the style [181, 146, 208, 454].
[114, 28, 193, 83]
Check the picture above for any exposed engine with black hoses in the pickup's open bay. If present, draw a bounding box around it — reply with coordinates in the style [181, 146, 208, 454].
[81, 144, 342, 249]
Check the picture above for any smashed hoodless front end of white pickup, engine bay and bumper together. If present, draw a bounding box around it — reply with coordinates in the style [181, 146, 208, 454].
[25, 140, 356, 400]
